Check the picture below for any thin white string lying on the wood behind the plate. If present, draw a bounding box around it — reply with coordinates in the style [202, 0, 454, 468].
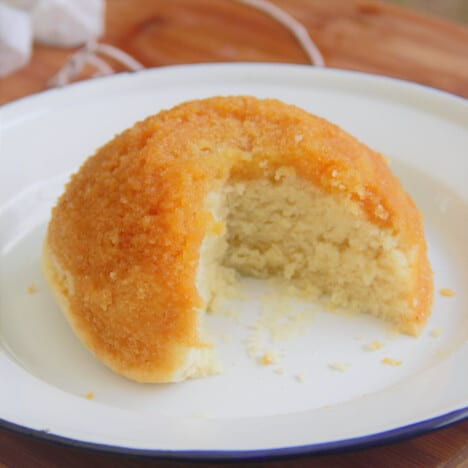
[47, 0, 325, 87]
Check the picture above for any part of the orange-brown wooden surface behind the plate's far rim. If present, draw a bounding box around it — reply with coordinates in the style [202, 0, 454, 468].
[0, 0, 468, 104]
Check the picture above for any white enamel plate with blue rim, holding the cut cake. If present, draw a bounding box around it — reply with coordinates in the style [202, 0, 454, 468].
[0, 64, 468, 459]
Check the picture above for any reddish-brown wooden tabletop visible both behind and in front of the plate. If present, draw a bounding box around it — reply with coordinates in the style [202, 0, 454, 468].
[0, 0, 468, 468]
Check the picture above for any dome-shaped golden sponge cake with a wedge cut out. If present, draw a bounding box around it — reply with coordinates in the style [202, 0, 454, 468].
[43, 97, 433, 382]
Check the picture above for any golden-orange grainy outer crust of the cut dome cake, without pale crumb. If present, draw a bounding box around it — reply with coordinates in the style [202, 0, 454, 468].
[44, 97, 432, 381]
